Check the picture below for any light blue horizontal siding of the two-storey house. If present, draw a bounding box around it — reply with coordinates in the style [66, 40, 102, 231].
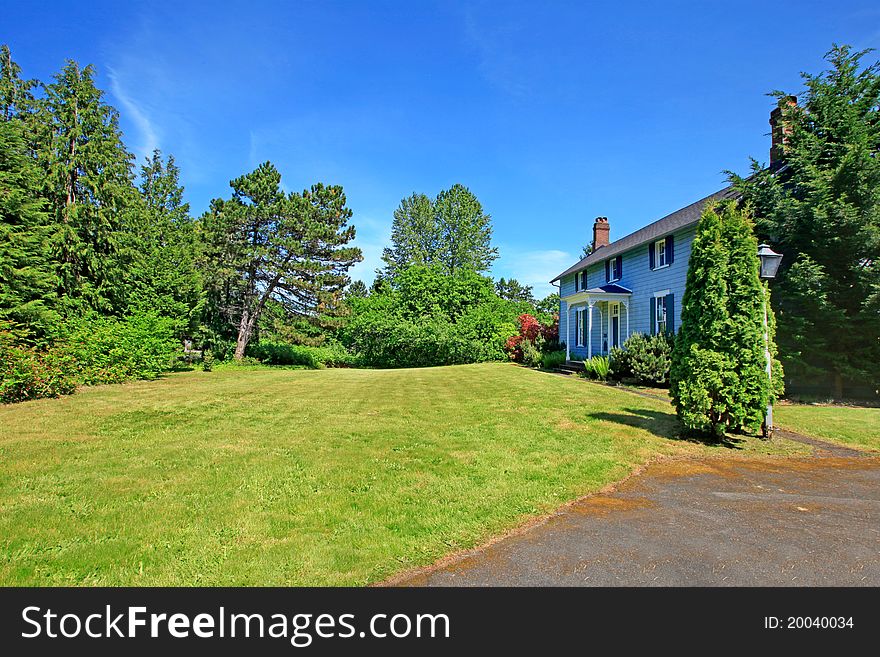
[559, 225, 696, 360]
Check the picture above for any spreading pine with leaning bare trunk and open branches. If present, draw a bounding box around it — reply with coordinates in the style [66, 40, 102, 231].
[202, 162, 361, 359]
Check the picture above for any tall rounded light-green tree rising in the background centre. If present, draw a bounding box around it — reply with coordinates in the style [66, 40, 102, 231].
[380, 184, 498, 281]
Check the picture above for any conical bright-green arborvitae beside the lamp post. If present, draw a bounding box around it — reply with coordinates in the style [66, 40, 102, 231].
[670, 202, 782, 436]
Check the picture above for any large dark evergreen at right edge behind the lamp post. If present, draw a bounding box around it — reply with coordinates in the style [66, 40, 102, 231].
[731, 46, 880, 397]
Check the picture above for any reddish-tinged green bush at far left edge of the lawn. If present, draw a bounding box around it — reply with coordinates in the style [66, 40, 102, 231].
[0, 330, 76, 403]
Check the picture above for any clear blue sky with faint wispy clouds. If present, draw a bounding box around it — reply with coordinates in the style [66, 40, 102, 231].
[6, 0, 880, 295]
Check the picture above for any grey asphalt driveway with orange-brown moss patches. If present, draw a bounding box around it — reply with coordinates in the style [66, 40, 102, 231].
[390, 444, 880, 586]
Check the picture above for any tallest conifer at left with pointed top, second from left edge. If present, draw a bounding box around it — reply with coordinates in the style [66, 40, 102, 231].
[39, 61, 135, 311]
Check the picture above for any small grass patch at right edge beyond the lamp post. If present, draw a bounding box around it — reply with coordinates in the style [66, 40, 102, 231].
[773, 404, 880, 450]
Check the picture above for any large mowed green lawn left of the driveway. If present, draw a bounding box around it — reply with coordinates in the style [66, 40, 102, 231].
[0, 364, 806, 585]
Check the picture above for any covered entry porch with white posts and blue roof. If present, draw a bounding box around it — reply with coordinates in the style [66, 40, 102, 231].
[560, 284, 632, 360]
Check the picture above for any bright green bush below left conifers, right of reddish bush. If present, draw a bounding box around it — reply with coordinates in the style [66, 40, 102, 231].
[58, 313, 182, 385]
